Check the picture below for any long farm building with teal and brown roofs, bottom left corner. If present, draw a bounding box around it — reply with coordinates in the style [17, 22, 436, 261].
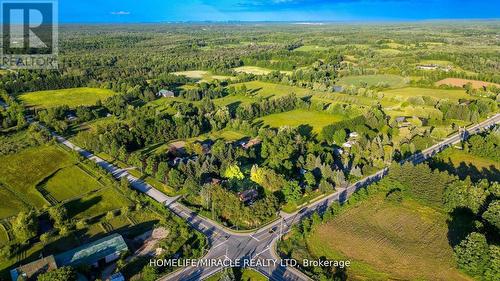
[10, 234, 128, 281]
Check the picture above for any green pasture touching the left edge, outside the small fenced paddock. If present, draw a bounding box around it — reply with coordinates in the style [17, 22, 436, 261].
[0, 146, 74, 209]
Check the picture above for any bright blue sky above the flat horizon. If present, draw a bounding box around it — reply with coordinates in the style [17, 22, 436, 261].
[59, 0, 500, 23]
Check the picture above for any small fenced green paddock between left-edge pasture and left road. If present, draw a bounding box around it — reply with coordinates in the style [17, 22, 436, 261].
[43, 165, 103, 202]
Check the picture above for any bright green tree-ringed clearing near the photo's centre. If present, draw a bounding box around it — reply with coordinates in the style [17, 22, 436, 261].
[257, 109, 344, 133]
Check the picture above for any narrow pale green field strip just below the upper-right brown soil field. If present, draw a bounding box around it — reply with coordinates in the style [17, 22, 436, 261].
[383, 87, 473, 100]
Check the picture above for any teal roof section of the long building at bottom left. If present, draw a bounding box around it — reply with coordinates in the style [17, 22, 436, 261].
[56, 234, 128, 266]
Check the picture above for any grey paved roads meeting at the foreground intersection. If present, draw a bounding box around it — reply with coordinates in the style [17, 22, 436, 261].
[54, 114, 500, 281]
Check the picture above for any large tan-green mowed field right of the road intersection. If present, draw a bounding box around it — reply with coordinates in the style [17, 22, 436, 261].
[307, 195, 471, 281]
